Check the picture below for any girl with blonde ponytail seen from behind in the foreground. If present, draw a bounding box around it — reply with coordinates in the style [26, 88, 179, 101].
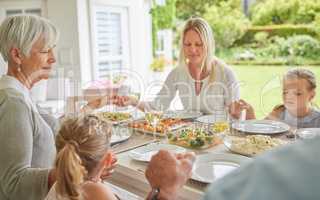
[46, 115, 116, 200]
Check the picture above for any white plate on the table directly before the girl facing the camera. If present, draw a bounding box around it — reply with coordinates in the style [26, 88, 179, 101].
[232, 120, 290, 135]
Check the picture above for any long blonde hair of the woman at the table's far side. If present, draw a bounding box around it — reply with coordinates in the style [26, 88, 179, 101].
[179, 17, 215, 72]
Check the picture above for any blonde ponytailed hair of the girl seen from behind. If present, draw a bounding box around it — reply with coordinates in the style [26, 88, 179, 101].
[55, 115, 111, 200]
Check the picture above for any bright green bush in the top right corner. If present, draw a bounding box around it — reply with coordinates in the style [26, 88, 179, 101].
[250, 0, 320, 25]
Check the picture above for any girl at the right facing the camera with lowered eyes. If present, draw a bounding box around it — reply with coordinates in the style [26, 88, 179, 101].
[233, 68, 320, 128]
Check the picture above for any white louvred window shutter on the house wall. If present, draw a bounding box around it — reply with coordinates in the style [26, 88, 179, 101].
[92, 5, 129, 79]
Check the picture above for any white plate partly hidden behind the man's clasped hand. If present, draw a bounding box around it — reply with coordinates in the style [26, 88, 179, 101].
[129, 143, 186, 162]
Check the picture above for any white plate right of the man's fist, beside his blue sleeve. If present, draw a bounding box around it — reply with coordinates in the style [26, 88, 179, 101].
[191, 153, 251, 183]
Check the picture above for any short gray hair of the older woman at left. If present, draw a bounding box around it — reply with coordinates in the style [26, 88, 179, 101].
[0, 15, 59, 61]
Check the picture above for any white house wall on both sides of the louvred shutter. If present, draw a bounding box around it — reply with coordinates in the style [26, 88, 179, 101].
[0, 0, 152, 92]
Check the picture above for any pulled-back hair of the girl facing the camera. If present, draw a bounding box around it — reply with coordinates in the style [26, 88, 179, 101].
[284, 68, 317, 90]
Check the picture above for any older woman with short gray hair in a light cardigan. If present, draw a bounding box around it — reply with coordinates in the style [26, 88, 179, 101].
[0, 15, 114, 200]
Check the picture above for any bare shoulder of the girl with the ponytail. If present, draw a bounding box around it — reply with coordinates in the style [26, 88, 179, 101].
[82, 181, 116, 200]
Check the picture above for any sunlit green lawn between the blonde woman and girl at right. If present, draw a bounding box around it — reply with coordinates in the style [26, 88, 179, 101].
[232, 65, 320, 119]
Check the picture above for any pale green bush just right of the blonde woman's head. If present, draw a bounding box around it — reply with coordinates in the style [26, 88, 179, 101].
[204, 0, 250, 48]
